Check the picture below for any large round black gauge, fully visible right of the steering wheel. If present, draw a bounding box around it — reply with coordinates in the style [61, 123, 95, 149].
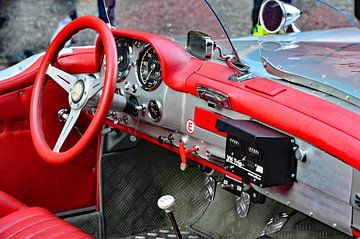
[138, 45, 162, 91]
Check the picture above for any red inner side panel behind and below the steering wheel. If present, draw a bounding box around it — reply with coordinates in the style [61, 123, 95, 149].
[0, 49, 97, 212]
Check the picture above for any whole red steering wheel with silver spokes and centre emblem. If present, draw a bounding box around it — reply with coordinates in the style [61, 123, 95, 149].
[30, 16, 117, 164]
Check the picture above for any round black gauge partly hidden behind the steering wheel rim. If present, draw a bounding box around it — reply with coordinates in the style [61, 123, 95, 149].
[116, 39, 132, 82]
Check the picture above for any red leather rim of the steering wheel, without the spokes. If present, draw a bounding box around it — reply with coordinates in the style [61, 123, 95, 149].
[30, 16, 117, 164]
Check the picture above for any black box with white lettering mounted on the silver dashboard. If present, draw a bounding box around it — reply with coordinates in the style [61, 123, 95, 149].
[216, 119, 296, 187]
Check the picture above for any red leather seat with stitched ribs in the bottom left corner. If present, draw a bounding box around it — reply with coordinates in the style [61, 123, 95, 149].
[0, 191, 92, 239]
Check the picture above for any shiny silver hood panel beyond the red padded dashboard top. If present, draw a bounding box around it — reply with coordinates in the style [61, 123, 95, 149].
[259, 27, 360, 106]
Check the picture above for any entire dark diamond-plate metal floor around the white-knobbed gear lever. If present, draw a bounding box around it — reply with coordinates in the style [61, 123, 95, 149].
[102, 141, 351, 239]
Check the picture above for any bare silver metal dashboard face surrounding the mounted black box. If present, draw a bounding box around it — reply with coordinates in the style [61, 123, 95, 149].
[109, 86, 352, 235]
